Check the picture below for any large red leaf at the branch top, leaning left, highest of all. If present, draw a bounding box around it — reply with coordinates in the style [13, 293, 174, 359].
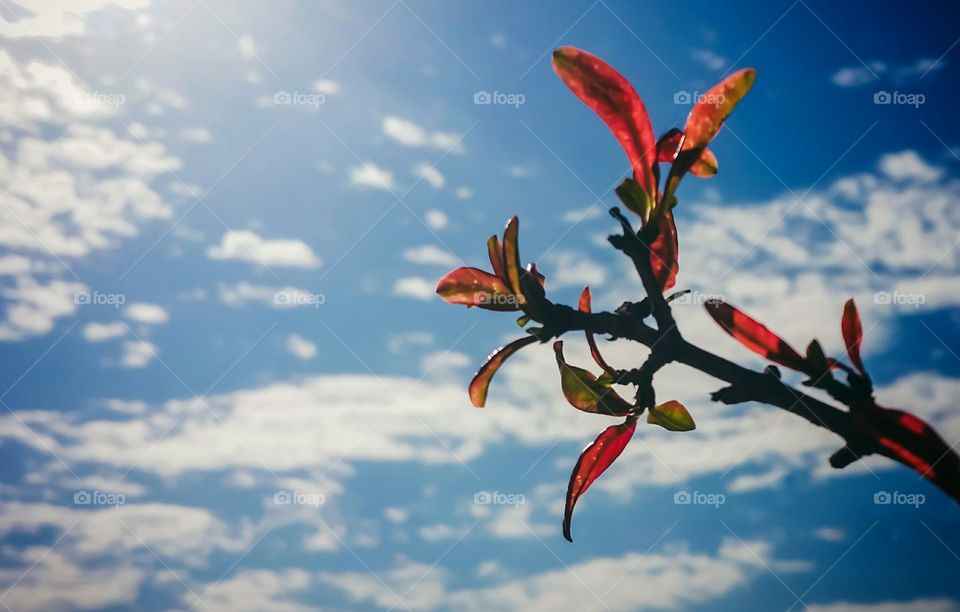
[553, 47, 657, 202]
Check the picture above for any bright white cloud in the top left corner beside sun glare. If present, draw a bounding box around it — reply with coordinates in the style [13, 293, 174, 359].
[0, 0, 150, 38]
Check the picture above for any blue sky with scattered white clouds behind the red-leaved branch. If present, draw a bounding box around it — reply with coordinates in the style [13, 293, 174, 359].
[0, 0, 960, 611]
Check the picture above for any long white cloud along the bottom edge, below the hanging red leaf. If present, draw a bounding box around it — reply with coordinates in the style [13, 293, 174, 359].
[319, 534, 808, 611]
